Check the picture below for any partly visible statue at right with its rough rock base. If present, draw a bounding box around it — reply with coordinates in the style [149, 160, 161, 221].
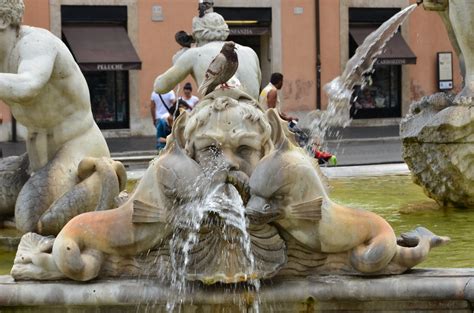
[408, 0, 474, 208]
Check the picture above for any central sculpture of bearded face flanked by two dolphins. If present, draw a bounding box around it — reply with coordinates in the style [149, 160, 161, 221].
[11, 94, 449, 284]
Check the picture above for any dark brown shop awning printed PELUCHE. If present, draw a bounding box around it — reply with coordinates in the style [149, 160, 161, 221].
[63, 25, 142, 71]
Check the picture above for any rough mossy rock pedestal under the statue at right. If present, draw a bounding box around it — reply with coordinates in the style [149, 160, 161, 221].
[400, 94, 474, 208]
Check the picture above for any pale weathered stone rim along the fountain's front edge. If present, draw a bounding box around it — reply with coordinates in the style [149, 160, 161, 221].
[0, 269, 474, 309]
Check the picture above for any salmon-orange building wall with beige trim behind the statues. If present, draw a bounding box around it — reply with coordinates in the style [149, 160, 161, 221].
[0, 0, 462, 141]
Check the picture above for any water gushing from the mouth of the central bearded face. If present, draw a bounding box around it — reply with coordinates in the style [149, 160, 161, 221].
[163, 158, 260, 312]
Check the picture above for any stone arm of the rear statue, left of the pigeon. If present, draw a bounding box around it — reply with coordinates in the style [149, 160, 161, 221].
[154, 50, 196, 94]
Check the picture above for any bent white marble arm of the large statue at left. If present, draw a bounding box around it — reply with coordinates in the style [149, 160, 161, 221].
[0, 38, 57, 103]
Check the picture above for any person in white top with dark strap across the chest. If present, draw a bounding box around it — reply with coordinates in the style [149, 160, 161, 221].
[150, 90, 176, 150]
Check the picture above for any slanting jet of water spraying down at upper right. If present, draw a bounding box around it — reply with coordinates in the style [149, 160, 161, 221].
[305, 4, 417, 150]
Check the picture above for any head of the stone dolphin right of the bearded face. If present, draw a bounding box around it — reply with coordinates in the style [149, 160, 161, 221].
[246, 108, 324, 222]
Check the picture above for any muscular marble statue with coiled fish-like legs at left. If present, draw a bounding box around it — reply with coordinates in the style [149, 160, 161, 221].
[0, 0, 121, 235]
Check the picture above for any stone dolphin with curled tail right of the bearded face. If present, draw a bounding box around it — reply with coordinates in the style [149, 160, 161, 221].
[247, 110, 449, 273]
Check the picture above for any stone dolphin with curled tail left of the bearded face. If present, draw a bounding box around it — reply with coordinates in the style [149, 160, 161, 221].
[11, 115, 201, 281]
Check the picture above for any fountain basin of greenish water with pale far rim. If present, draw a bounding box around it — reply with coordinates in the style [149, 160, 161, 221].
[0, 164, 474, 275]
